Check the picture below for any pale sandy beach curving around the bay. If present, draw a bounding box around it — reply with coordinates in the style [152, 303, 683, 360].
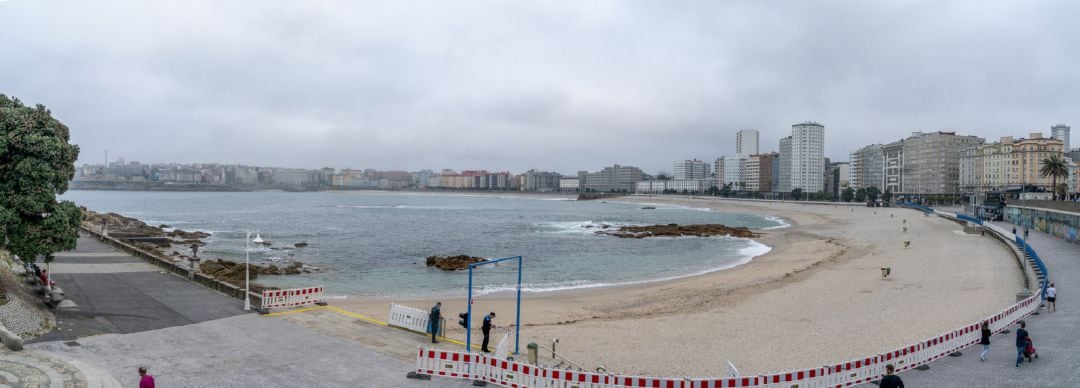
[332, 198, 1023, 376]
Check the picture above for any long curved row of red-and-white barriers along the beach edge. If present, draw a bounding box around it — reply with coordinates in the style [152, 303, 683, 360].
[416, 291, 1041, 388]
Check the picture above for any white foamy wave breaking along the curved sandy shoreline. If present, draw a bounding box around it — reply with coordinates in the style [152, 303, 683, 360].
[476, 238, 772, 295]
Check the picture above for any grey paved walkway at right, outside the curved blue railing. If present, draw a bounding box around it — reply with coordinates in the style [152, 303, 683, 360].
[876, 223, 1080, 387]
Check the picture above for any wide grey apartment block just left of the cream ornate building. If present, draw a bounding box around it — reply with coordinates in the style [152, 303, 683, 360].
[887, 132, 984, 195]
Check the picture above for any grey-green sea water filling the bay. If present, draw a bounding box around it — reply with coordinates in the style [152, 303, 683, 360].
[62, 191, 785, 297]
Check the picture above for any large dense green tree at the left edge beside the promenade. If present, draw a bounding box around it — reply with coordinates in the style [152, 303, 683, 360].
[0, 94, 82, 262]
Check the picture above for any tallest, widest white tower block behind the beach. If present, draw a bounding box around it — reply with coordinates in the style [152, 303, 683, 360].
[791, 121, 825, 192]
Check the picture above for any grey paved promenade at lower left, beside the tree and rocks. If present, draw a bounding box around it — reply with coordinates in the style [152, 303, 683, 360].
[0, 238, 468, 388]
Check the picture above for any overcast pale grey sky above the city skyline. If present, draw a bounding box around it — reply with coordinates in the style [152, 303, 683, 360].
[0, 0, 1080, 173]
